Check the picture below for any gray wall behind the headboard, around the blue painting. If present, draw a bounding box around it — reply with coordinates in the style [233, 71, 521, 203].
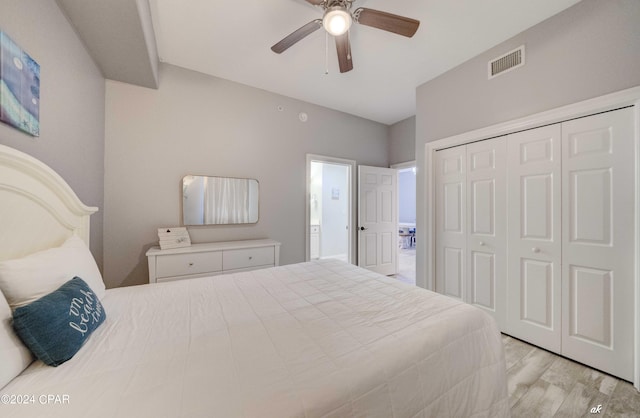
[0, 0, 105, 267]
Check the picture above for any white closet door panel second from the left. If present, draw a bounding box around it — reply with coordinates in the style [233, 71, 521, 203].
[467, 137, 507, 329]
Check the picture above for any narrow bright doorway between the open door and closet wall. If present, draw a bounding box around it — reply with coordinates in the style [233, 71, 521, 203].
[391, 161, 416, 285]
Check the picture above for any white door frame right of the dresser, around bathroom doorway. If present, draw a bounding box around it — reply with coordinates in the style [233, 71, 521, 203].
[304, 154, 356, 264]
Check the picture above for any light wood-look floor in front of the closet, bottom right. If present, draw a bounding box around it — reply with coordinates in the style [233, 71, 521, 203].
[502, 335, 640, 418]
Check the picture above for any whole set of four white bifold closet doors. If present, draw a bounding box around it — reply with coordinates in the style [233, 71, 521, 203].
[434, 107, 636, 380]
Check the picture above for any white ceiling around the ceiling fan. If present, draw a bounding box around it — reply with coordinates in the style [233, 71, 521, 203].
[149, 0, 579, 125]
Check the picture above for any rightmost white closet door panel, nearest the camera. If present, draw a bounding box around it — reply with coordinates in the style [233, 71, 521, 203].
[562, 108, 635, 380]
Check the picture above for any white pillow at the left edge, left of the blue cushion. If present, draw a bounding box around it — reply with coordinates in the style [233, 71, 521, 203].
[0, 293, 33, 388]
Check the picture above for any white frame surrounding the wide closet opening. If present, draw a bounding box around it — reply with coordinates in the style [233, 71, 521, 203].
[416, 86, 640, 390]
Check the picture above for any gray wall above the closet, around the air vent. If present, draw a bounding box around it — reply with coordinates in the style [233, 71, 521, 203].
[416, 0, 640, 286]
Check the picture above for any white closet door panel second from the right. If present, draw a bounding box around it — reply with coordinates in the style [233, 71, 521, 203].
[507, 124, 562, 353]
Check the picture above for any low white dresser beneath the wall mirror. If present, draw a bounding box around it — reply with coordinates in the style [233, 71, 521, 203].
[147, 239, 280, 283]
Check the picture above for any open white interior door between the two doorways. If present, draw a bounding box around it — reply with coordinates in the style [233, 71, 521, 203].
[358, 165, 398, 275]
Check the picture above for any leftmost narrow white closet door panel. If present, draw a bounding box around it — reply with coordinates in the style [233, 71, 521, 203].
[435, 146, 467, 301]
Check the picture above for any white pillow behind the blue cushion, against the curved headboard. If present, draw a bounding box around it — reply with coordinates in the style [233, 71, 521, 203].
[0, 236, 104, 309]
